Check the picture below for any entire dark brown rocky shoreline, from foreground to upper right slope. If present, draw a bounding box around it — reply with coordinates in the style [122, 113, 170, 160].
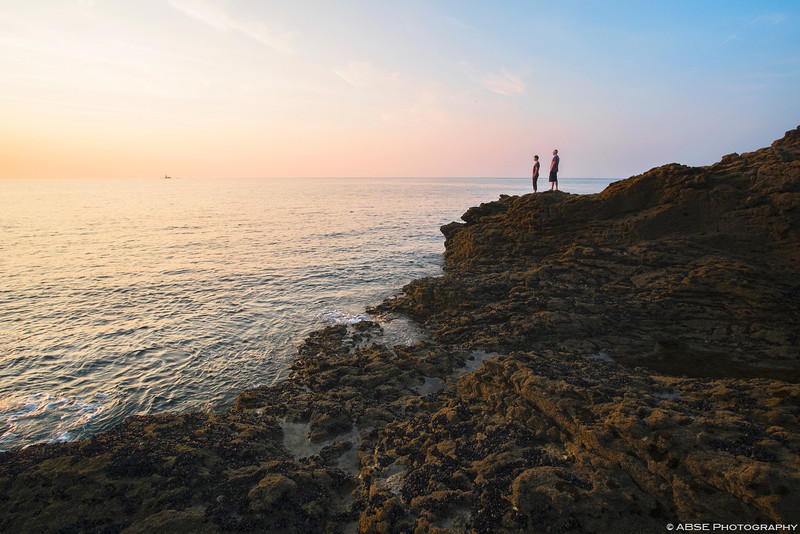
[0, 130, 800, 533]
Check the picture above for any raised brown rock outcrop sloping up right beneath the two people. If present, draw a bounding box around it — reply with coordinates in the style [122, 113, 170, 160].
[392, 130, 800, 382]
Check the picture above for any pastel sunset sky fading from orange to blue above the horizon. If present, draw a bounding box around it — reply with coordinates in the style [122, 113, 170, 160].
[0, 0, 800, 179]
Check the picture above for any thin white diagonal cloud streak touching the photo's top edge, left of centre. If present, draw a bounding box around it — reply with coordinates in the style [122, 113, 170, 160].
[168, 0, 294, 55]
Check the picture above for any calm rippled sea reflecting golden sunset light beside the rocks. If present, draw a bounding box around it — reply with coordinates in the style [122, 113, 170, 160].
[0, 178, 611, 450]
